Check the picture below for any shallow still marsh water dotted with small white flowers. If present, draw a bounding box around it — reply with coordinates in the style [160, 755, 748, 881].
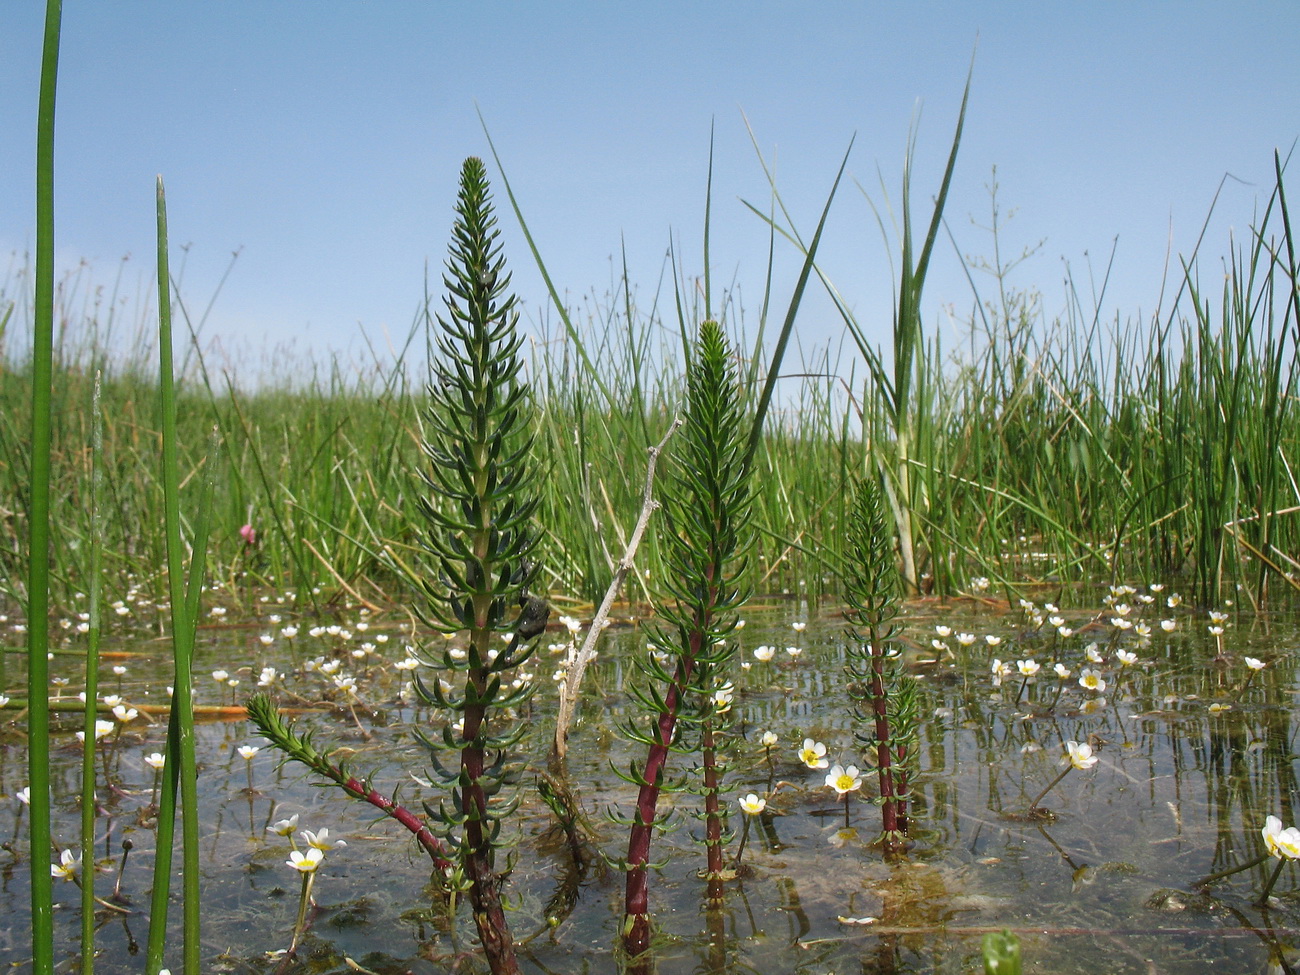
[0, 597, 1300, 975]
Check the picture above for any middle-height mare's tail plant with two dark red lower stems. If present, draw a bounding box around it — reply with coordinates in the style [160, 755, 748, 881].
[620, 321, 753, 957]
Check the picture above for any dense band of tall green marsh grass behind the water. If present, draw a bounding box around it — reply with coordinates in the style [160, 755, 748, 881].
[0, 157, 1300, 625]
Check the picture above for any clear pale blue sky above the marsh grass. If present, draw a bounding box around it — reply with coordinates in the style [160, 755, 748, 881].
[0, 0, 1300, 377]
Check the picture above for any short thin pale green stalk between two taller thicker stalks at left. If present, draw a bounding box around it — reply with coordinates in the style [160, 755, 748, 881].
[81, 374, 107, 975]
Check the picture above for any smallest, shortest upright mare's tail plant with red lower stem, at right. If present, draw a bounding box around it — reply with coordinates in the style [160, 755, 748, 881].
[842, 478, 919, 853]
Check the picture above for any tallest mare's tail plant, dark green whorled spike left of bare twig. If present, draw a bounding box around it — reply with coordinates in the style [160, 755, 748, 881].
[416, 159, 550, 975]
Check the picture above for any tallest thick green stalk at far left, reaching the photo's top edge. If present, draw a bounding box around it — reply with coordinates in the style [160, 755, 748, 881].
[27, 0, 62, 975]
